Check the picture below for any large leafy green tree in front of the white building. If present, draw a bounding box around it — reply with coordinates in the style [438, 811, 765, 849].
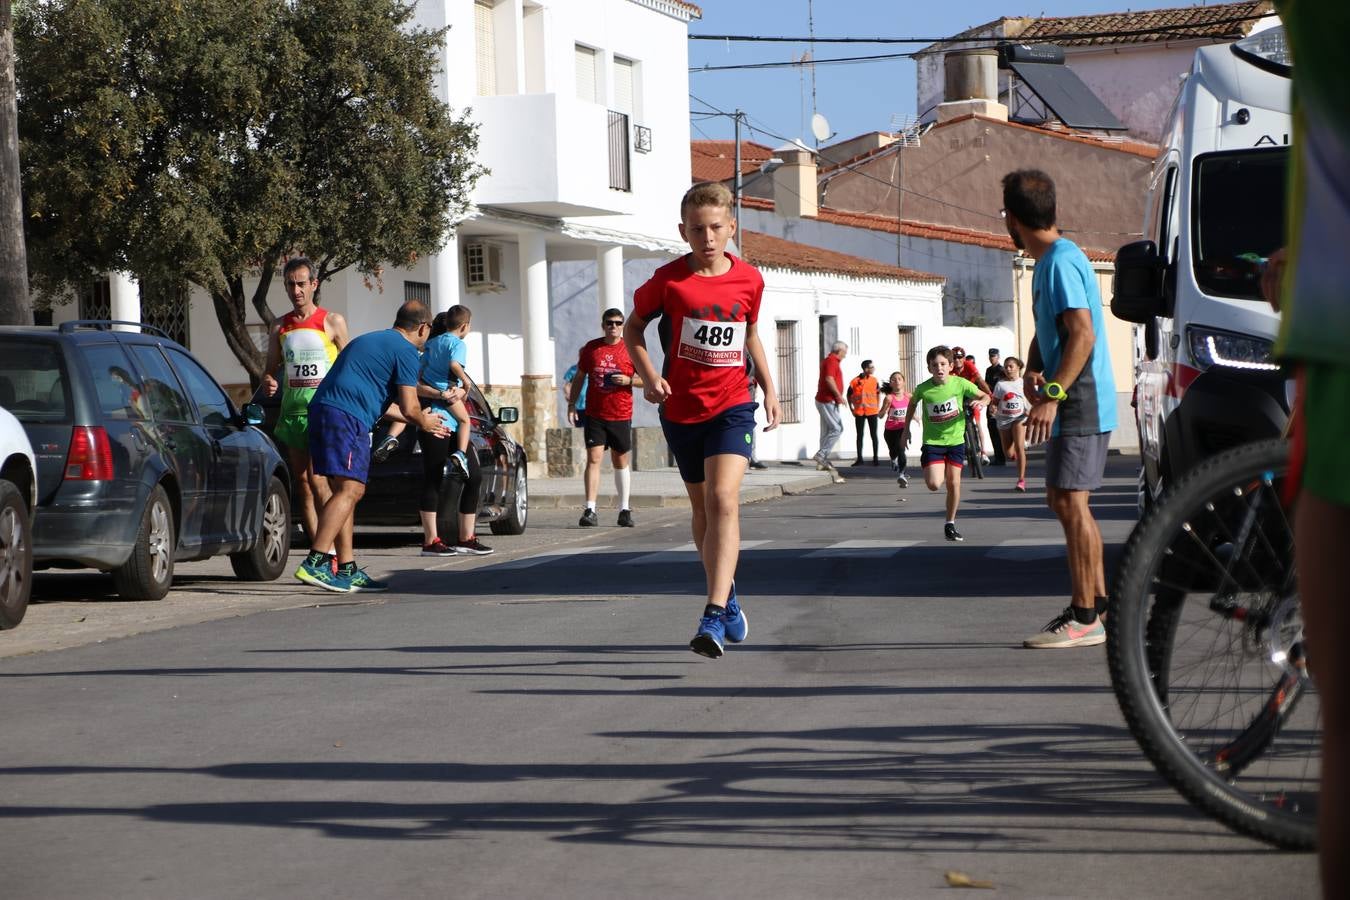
[15, 0, 482, 383]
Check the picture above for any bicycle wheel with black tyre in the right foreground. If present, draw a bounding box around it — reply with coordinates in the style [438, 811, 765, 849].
[1107, 441, 1322, 849]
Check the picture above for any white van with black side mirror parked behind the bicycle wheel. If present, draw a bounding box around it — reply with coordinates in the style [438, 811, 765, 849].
[1111, 19, 1292, 506]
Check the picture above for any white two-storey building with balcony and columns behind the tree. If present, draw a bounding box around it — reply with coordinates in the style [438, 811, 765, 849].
[53, 0, 699, 460]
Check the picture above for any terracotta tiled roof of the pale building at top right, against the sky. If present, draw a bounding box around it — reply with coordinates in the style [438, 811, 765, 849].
[1008, 0, 1274, 47]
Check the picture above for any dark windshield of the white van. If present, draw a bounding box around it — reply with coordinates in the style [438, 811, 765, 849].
[1193, 147, 1289, 302]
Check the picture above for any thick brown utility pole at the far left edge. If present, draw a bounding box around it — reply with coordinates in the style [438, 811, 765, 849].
[0, 0, 32, 325]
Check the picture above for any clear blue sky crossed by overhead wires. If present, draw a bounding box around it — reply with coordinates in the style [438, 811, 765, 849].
[689, 0, 1216, 147]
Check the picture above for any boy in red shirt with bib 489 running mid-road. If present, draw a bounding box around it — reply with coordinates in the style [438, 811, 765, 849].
[624, 184, 779, 660]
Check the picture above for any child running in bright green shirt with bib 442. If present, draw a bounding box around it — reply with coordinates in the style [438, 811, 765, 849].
[903, 345, 991, 541]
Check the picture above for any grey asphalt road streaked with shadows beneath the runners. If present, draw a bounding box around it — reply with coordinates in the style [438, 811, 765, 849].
[0, 457, 1316, 900]
